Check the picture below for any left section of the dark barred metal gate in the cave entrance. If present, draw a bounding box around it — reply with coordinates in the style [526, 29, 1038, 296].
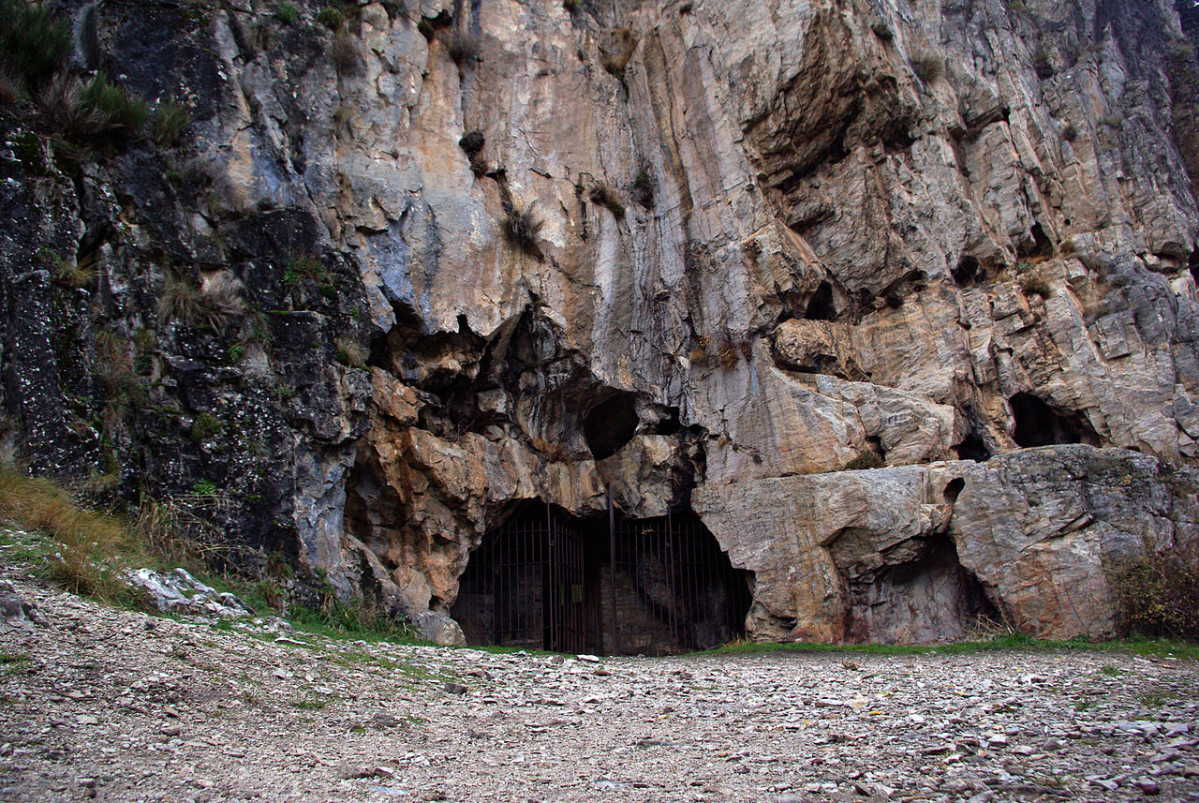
[456, 505, 585, 652]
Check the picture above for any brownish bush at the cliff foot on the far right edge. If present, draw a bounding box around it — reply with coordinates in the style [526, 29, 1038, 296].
[1108, 544, 1199, 640]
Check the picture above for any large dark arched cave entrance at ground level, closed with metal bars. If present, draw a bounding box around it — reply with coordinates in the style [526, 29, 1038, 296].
[451, 502, 751, 656]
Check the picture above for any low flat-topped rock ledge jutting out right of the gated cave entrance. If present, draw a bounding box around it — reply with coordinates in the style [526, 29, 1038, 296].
[697, 446, 1199, 641]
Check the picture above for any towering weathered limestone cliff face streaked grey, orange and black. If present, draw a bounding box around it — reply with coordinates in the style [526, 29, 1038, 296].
[0, 0, 1199, 640]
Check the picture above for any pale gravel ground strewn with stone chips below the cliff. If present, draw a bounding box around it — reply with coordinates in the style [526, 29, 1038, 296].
[0, 569, 1199, 803]
